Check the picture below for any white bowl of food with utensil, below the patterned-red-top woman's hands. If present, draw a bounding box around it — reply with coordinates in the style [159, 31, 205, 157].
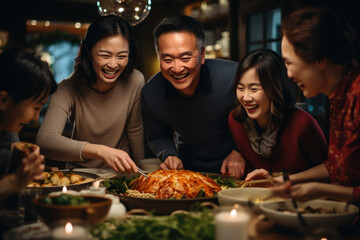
[260, 200, 359, 230]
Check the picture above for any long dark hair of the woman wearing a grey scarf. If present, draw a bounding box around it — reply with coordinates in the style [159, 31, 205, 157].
[233, 49, 296, 122]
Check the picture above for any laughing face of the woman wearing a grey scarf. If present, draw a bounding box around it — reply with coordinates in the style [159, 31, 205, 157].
[236, 68, 271, 128]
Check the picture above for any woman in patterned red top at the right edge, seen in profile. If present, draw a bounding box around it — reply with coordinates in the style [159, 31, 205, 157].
[248, 8, 360, 203]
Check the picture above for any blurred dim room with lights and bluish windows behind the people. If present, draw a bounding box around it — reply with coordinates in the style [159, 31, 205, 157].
[0, 0, 360, 146]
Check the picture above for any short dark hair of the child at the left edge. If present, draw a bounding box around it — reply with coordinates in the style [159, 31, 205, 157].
[0, 49, 57, 103]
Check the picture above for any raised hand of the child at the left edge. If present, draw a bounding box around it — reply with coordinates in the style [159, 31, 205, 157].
[14, 146, 45, 190]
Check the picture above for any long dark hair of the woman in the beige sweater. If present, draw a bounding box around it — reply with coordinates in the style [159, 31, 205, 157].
[75, 14, 137, 87]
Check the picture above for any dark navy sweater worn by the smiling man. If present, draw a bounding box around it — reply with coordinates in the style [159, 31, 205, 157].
[142, 59, 238, 173]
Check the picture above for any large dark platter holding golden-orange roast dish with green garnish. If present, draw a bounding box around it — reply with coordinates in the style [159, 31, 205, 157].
[103, 170, 238, 215]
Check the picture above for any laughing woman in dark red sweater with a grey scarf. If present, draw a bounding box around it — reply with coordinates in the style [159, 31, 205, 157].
[228, 50, 327, 176]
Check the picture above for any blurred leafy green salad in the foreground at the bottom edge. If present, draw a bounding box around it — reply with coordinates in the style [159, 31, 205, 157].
[91, 208, 215, 240]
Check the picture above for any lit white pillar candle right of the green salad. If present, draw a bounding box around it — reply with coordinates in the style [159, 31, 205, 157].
[215, 209, 250, 240]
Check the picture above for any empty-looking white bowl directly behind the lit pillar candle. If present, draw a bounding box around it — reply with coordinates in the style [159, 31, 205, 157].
[217, 187, 283, 209]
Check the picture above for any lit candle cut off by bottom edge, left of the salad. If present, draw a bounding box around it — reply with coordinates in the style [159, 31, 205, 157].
[52, 222, 88, 240]
